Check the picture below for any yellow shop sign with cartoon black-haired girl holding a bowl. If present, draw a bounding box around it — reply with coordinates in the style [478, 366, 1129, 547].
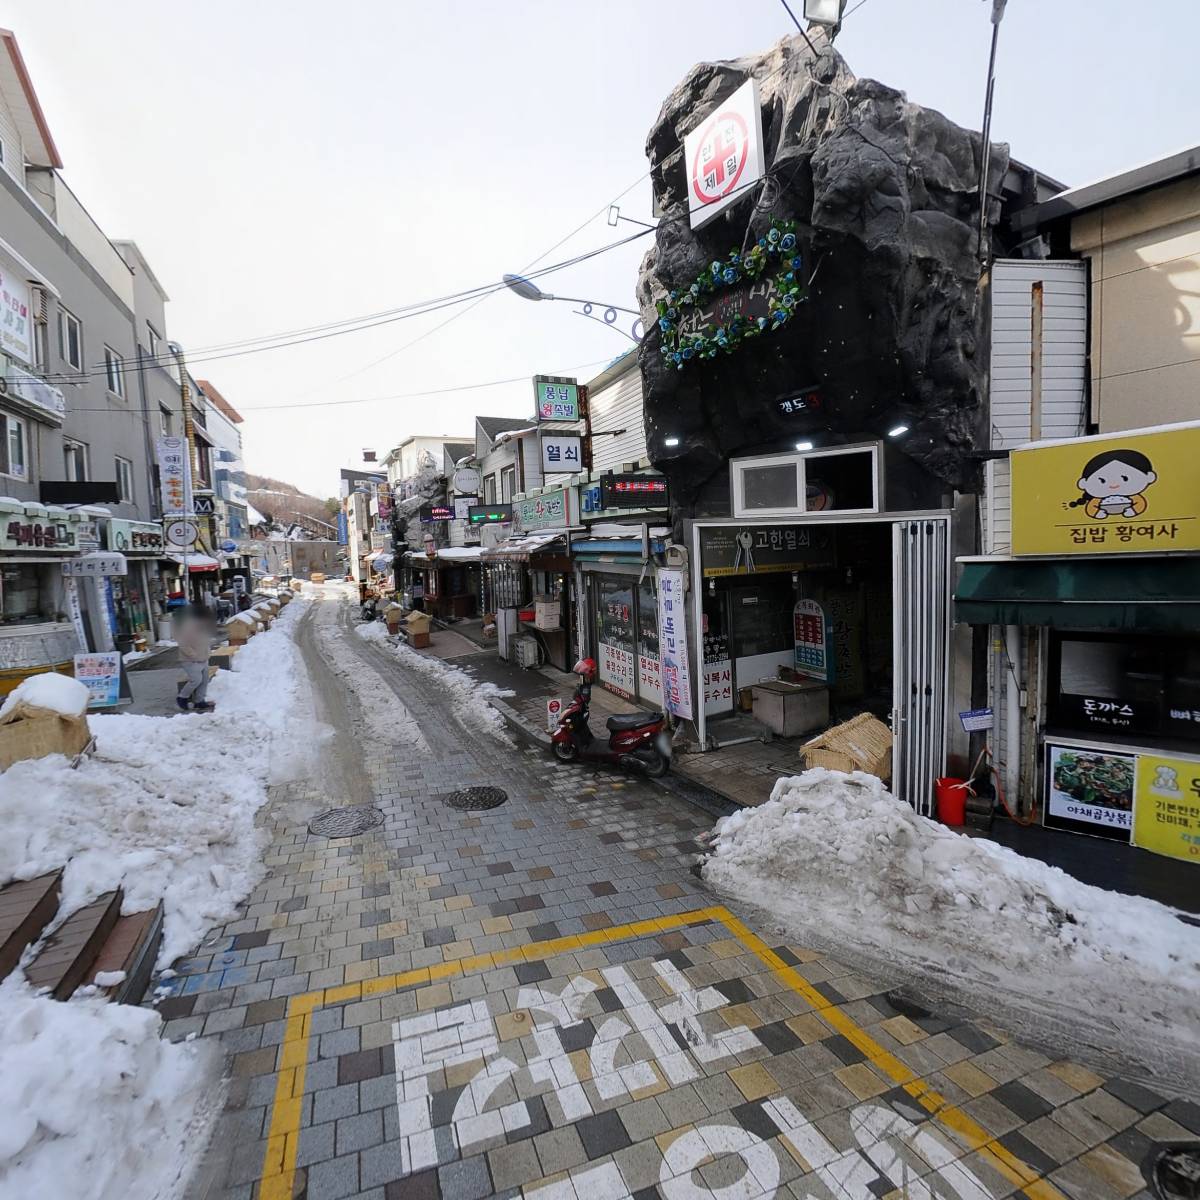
[1010, 422, 1200, 554]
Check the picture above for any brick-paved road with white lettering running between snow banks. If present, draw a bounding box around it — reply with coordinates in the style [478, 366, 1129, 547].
[171, 596, 1200, 1200]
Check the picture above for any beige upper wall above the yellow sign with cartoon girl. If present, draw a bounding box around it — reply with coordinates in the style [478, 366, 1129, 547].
[1070, 179, 1200, 433]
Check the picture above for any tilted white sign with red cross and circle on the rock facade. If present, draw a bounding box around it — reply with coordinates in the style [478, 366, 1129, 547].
[683, 79, 764, 229]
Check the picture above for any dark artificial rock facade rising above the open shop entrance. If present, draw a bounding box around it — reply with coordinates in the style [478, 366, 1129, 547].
[637, 34, 1009, 509]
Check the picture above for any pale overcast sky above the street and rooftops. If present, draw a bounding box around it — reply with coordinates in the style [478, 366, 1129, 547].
[11, 0, 1200, 496]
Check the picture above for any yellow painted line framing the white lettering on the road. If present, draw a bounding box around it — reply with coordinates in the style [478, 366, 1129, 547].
[259, 905, 1064, 1200]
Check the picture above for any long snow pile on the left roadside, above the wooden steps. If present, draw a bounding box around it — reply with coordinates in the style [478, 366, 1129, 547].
[0, 592, 320, 965]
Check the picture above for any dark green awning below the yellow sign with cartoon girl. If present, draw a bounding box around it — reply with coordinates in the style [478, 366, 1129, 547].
[954, 557, 1200, 634]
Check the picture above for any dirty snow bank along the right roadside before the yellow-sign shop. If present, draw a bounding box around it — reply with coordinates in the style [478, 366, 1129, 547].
[704, 770, 1200, 1081]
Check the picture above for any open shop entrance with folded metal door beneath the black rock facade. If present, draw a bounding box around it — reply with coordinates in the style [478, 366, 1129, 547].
[695, 517, 949, 811]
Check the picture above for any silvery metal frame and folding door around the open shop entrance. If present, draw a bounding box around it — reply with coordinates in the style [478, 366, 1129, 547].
[690, 509, 953, 812]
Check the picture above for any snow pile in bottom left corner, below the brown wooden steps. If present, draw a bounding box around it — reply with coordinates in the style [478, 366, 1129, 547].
[0, 976, 220, 1200]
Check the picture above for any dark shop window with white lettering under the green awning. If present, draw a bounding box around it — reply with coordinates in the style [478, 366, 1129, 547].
[1048, 632, 1200, 742]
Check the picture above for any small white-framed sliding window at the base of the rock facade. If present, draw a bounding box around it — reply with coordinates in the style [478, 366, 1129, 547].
[730, 444, 882, 517]
